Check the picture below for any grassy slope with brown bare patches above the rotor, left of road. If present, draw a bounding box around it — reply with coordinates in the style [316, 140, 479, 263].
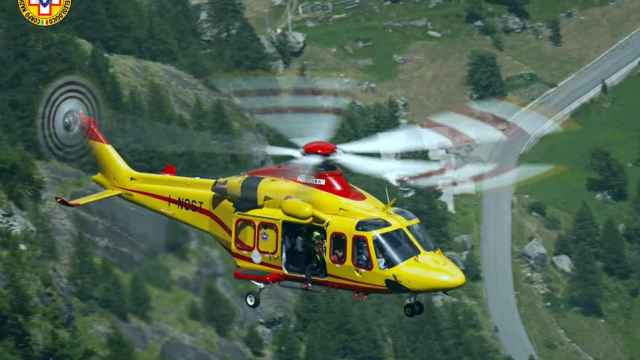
[250, 0, 640, 119]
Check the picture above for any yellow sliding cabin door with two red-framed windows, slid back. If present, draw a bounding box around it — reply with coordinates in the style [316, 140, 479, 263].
[231, 211, 282, 268]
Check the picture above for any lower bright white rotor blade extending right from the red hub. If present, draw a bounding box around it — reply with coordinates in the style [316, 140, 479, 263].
[331, 153, 442, 182]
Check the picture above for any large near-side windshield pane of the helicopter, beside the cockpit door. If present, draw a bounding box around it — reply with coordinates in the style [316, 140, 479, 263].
[373, 229, 420, 270]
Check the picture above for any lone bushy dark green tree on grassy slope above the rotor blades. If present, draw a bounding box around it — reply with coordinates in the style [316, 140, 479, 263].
[467, 50, 507, 99]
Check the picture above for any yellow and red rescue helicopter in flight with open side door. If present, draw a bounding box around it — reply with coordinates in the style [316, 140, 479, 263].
[56, 114, 465, 317]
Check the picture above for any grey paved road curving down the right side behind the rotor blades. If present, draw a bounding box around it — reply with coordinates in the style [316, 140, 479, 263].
[481, 28, 640, 360]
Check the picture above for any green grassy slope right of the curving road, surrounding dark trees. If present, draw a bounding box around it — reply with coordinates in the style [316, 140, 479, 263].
[514, 74, 640, 359]
